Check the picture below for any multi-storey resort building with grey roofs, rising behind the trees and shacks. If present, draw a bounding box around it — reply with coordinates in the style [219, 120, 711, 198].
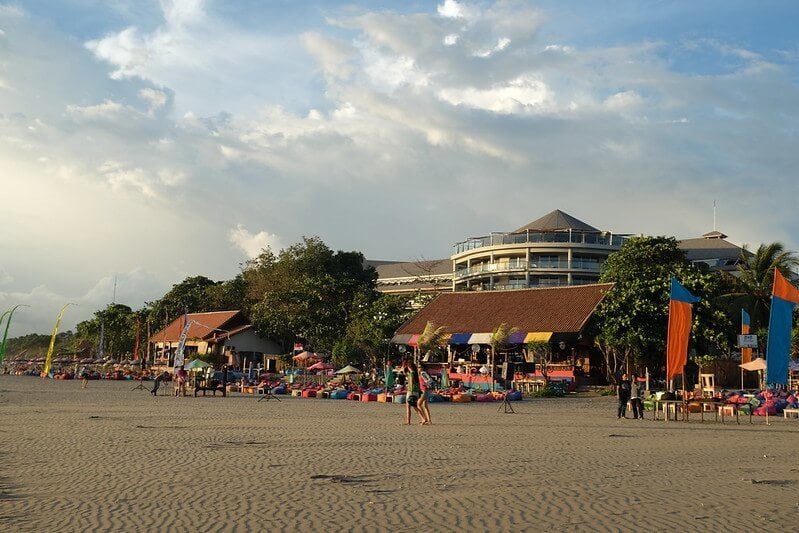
[376, 210, 742, 294]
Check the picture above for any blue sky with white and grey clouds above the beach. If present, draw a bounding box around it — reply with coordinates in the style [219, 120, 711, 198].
[0, 0, 799, 335]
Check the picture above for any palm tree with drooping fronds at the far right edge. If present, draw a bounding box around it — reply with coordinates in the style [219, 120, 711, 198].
[725, 242, 799, 330]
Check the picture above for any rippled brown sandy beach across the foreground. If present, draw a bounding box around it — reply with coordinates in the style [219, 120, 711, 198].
[0, 376, 799, 532]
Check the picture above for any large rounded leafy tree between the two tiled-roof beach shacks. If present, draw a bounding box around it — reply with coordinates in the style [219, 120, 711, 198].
[242, 237, 377, 351]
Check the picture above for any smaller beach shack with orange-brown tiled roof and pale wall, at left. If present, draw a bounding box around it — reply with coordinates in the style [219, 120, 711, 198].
[149, 310, 280, 371]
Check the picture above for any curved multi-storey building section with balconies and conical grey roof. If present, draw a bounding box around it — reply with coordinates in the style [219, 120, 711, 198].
[450, 210, 629, 291]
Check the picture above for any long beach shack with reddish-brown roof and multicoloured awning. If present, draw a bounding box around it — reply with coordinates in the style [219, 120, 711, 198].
[391, 283, 613, 389]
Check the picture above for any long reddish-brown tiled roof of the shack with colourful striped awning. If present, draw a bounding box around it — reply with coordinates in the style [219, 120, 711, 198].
[397, 283, 613, 335]
